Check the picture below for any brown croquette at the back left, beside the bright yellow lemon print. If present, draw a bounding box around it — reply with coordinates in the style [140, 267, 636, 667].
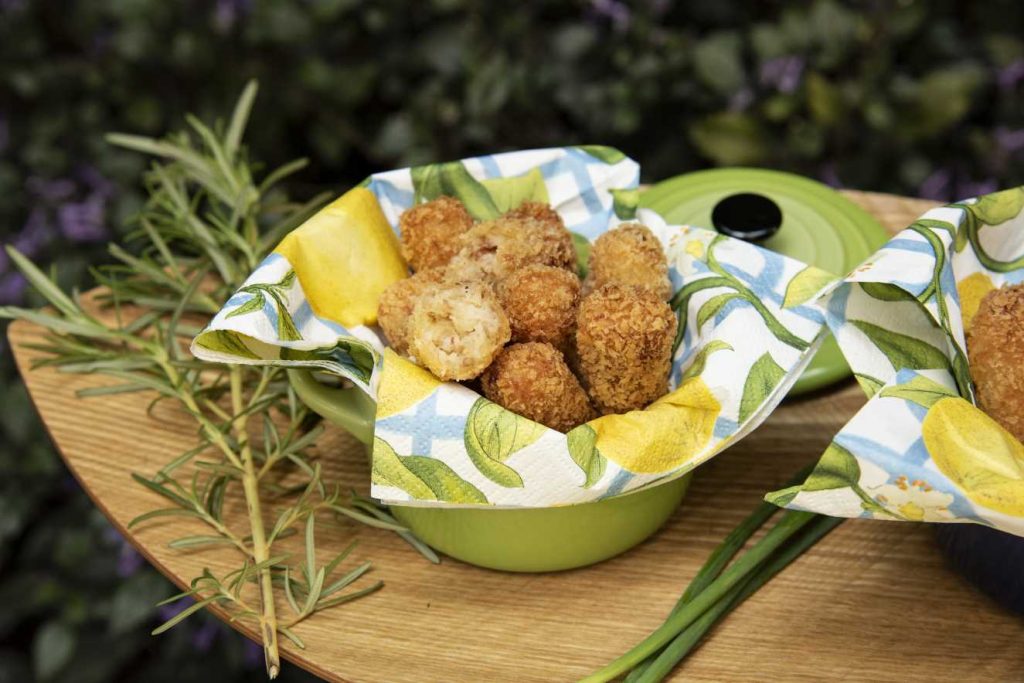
[398, 197, 474, 270]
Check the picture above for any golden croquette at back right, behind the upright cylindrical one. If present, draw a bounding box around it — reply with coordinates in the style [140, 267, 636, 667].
[584, 223, 672, 301]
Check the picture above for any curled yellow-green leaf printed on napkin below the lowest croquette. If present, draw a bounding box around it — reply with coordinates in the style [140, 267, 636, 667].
[465, 398, 544, 488]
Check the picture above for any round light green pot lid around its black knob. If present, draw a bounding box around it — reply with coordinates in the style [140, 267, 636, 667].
[640, 168, 889, 395]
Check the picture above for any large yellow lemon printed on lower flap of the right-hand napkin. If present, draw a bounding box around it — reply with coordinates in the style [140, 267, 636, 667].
[923, 397, 1024, 516]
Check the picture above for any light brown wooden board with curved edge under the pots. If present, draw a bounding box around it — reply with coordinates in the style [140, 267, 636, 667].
[9, 188, 1024, 683]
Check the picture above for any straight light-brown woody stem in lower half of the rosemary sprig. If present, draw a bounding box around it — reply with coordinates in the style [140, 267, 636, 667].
[230, 366, 281, 679]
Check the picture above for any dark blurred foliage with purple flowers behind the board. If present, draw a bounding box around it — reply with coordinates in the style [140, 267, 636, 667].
[0, 0, 1024, 683]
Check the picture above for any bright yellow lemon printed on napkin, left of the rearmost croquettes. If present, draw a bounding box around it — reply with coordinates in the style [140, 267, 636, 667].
[274, 187, 409, 328]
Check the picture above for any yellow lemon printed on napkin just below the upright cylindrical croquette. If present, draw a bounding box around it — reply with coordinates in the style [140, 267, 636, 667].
[588, 377, 722, 474]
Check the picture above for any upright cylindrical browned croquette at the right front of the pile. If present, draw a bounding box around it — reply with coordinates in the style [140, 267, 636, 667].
[575, 285, 678, 415]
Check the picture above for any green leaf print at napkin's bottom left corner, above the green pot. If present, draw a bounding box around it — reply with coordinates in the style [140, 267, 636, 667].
[372, 437, 487, 503]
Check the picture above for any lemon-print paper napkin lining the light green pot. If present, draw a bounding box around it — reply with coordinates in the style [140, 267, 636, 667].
[193, 146, 838, 507]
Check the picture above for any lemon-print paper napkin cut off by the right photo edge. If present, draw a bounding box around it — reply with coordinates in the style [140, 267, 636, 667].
[767, 188, 1024, 536]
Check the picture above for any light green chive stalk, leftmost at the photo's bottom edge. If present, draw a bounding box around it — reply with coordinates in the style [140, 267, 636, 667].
[581, 510, 815, 683]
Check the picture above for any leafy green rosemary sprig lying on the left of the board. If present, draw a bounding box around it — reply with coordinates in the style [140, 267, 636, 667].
[0, 83, 423, 678]
